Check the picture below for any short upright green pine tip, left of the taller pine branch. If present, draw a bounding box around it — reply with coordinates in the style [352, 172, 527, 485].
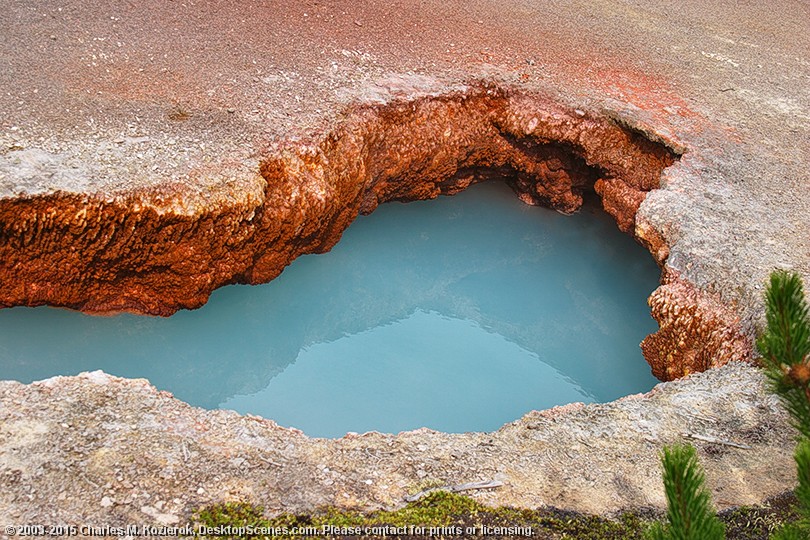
[648, 445, 725, 540]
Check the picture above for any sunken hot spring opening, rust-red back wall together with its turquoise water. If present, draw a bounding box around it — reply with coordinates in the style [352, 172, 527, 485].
[0, 85, 677, 437]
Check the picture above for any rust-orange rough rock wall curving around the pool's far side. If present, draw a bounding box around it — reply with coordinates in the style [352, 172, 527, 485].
[0, 83, 750, 380]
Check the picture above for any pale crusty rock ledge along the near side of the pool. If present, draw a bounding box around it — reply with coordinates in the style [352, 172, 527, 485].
[0, 362, 795, 525]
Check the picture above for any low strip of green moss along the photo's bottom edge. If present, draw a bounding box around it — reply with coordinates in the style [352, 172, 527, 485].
[195, 491, 795, 540]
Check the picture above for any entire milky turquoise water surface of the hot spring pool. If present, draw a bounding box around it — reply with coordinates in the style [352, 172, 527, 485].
[0, 183, 658, 437]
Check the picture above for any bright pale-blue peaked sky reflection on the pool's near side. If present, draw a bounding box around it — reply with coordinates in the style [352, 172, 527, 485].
[223, 309, 595, 436]
